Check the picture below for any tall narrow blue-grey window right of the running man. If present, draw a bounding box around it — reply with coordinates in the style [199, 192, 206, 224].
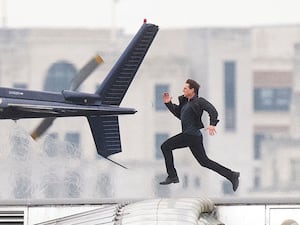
[224, 61, 236, 131]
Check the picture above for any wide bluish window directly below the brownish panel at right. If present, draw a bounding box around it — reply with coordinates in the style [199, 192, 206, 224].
[254, 88, 292, 111]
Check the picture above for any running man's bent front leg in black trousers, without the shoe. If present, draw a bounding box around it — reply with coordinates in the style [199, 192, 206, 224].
[161, 133, 187, 182]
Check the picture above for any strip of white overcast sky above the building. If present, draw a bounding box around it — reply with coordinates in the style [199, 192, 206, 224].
[0, 0, 300, 32]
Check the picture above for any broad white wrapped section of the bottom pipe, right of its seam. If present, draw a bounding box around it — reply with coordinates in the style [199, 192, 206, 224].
[117, 198, 214, 225]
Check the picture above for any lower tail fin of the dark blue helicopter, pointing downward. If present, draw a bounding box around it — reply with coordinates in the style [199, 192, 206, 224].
[87, 116, 122, 158]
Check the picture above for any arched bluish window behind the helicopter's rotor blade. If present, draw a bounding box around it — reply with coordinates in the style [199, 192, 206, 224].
[44, 61, 77, 92]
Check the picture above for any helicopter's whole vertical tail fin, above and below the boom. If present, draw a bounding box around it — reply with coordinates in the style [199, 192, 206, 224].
[87, 23, 158, 159]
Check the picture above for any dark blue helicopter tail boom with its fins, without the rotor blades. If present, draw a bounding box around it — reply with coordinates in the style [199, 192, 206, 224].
[0, 22, 158, 162]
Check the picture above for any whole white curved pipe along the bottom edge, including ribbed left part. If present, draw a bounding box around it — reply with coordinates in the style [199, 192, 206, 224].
[34, 198, 222, 225]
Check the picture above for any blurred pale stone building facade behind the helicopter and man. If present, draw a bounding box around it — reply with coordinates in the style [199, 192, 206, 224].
[0, 25, 300, 199]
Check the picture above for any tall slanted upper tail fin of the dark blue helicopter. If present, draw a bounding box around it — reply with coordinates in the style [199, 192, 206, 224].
[96, 23, 158, 105]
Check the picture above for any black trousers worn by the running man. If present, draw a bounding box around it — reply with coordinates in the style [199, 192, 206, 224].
[161, 133, 232, 180]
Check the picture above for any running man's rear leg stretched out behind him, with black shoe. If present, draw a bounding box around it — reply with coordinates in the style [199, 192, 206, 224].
[188, 135, 239, 191]
